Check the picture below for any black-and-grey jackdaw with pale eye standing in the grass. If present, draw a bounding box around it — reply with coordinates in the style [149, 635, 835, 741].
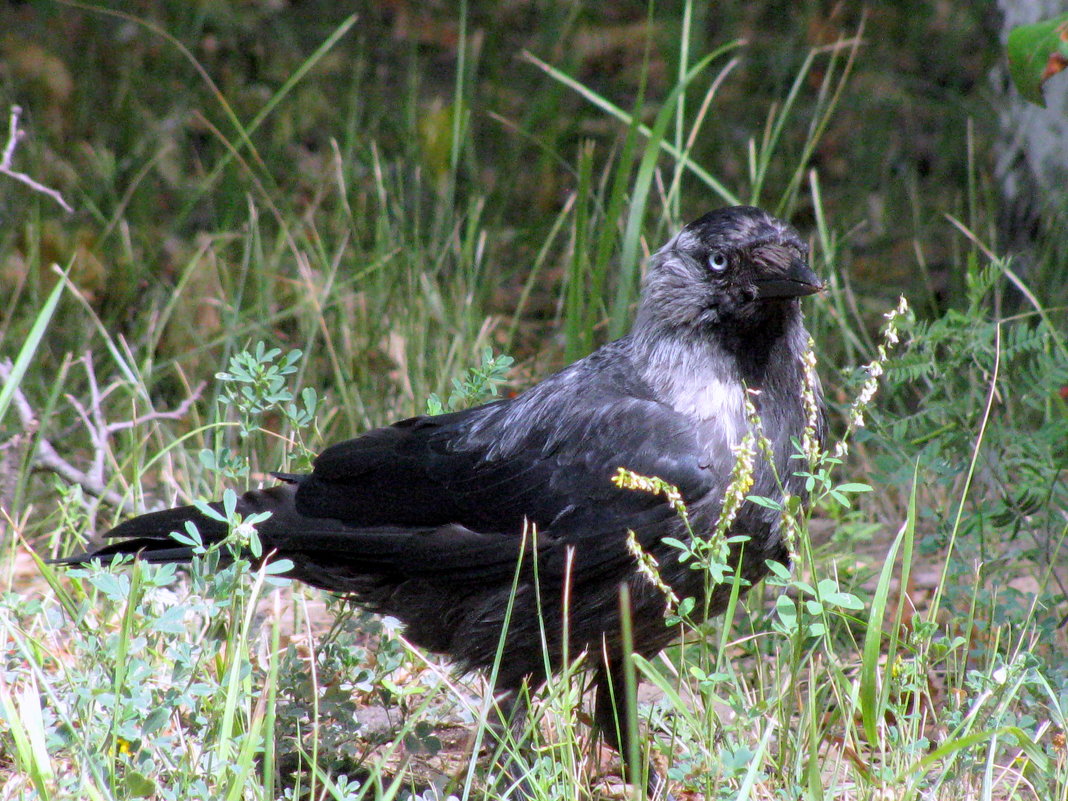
[61, 206, 826, 798]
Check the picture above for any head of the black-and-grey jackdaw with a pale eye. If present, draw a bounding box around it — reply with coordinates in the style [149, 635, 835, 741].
[638, 206, 822, 333]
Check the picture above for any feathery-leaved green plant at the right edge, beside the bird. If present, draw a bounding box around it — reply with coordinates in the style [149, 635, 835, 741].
[873, 254, 1068, 623]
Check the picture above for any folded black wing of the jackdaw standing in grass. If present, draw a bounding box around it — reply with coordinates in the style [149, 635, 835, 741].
[296, 388, 723, 580]
